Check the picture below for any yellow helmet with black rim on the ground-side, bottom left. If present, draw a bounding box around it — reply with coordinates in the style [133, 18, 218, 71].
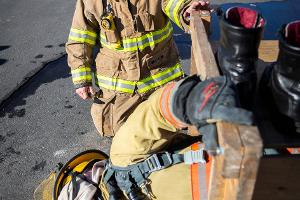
[53, 149, 108, 200]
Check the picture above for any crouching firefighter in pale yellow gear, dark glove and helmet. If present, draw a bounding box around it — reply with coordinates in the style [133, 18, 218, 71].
[41, 76, 253, 200]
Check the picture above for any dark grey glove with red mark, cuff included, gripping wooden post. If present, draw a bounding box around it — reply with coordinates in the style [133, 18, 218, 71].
[173, 75, 253, 155]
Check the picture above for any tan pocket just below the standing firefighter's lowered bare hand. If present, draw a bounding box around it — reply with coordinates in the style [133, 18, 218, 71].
[91, 95, 115, 137]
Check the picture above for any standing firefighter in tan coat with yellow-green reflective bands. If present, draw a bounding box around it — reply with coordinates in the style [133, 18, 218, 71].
[66, 0, 209, 136]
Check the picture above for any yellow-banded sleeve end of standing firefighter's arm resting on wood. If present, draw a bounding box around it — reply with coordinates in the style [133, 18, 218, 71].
[162, 0, 193, 32]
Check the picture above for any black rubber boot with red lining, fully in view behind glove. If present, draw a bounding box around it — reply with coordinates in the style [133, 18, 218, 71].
[217, 7, 265, 109]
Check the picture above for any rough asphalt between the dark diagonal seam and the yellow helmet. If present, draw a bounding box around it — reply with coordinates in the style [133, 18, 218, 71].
[0, 57, 110, 200]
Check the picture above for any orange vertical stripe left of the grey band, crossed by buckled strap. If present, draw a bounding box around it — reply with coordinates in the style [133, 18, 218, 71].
[191, 143, 200, 200]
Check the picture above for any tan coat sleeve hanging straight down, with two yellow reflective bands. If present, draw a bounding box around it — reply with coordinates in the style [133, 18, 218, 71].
[66, 0, 99, 88]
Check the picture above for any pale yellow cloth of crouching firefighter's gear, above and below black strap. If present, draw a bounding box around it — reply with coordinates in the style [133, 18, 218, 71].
[110, 88, 210, 200]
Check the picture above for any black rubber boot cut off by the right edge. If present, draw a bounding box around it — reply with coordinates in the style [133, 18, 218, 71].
[270, 21, 300, 132]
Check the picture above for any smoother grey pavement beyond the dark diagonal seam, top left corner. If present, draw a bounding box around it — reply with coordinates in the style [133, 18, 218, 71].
[0, 0, 75, 103]
